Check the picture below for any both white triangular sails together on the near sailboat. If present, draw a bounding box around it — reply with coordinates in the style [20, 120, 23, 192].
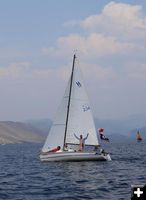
[42, 55, 99, 152]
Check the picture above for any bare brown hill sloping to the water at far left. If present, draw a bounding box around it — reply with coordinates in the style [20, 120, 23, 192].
[0, 121, 45, 144]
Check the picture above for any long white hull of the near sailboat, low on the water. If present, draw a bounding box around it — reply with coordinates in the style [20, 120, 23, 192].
[40, 152, 111, 161]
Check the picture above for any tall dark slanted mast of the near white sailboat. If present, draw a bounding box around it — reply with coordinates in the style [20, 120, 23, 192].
[63, 54, 76, 149]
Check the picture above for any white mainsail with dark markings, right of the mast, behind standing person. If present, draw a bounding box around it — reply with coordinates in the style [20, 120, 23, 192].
[66, 57, 99, 145]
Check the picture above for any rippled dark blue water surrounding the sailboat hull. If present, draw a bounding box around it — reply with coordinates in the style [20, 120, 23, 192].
[0, 142, 146, 200]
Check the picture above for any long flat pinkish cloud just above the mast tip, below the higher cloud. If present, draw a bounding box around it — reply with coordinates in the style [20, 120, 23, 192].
[42, 32, 141, 59]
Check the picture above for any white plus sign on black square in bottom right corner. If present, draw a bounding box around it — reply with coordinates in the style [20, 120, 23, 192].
[131, 185, 146, 200]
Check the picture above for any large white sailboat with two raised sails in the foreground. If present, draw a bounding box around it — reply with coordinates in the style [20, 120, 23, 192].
[40, 55, 111, 161]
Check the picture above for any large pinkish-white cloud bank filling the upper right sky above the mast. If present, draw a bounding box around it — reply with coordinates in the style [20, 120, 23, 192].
[42, 1, 146, 59]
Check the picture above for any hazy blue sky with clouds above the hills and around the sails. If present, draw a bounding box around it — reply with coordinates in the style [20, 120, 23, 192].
[0, 0, 146, 121]
